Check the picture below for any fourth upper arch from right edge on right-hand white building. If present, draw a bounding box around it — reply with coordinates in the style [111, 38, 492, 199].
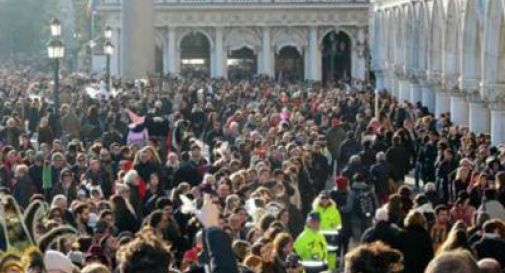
[429, 0, 444, 74]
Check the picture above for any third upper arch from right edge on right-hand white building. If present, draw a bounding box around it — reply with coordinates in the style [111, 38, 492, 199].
[443, 0, 460, 85]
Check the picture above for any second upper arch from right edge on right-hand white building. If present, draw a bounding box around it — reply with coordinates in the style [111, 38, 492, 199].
[461, 0, 482, 86]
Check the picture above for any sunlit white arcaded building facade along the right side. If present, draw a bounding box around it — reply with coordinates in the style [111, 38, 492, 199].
[370, 0, 505, 144]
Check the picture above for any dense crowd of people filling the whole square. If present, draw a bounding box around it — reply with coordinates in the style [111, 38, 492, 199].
[0, 61, 505, 273]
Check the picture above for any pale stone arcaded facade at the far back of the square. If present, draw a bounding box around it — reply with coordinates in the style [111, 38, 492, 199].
[93, 0, 369, 81]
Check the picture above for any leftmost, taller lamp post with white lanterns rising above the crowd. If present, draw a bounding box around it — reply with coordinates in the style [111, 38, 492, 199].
[47, 18, 65, 135]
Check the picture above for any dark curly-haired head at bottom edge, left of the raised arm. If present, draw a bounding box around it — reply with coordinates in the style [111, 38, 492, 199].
[117, 228, 172, 273]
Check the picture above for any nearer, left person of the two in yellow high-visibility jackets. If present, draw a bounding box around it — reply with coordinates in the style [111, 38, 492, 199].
[293, 212, 328, 262]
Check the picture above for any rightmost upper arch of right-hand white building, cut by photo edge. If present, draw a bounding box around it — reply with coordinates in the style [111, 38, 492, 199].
[482, 1, 505, 84]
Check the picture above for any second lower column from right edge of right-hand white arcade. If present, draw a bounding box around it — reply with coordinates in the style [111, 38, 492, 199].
[467, 93, 491, 134]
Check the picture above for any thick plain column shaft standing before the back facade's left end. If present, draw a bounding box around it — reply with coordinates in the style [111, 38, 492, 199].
[121, 0, 155, 79]
